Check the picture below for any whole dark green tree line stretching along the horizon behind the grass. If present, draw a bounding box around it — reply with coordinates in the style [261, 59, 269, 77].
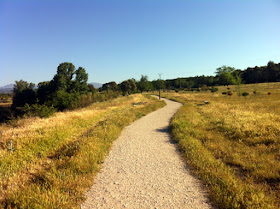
[4, 61, 280, 121]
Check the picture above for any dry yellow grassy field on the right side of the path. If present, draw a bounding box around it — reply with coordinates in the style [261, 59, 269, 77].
[160, 83, 280, 208]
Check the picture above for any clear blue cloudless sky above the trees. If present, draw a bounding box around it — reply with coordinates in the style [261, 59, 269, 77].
[0, 0, 280, 86]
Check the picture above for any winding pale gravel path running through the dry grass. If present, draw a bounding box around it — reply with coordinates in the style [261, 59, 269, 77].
[81, 100, 211, 208]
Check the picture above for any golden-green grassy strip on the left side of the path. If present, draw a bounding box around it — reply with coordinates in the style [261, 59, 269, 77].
[0, 95, 165, 208]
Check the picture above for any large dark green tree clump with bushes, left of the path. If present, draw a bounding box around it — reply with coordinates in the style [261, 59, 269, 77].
[12, 62, 92, 117]
